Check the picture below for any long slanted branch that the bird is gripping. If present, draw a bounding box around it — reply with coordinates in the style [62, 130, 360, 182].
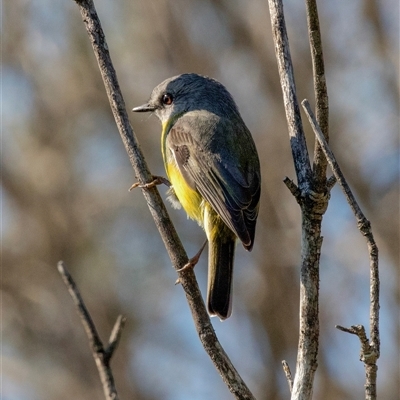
[70, 0, 254, 399]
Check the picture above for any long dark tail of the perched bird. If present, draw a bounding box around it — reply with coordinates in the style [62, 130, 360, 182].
[206, 217, 236, 320]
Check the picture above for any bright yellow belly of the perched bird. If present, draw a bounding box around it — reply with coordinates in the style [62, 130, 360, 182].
[166, 160, 204, 226]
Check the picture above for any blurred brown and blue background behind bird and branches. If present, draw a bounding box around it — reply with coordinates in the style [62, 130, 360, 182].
[1, 0, 400, 400]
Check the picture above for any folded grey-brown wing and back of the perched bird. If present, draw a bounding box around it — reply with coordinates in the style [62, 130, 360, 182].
[167, 114, 260, 250]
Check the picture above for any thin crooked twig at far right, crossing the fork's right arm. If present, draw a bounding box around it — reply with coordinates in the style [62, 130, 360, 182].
[302, 100, 380, 400]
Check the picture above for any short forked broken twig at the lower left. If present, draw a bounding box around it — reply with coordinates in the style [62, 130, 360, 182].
[57, 261, 125, 400]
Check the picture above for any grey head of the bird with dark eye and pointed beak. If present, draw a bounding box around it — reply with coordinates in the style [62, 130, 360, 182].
[133, 74, 239, 123]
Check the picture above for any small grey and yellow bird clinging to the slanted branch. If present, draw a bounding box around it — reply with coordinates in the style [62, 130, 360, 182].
[133, 74, 261, 320]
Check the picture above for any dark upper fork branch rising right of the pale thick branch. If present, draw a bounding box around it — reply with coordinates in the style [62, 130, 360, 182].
[306, 0, 329, 193]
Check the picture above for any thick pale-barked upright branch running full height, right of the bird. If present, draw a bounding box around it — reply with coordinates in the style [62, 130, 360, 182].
[269, 0, 329, 400]
